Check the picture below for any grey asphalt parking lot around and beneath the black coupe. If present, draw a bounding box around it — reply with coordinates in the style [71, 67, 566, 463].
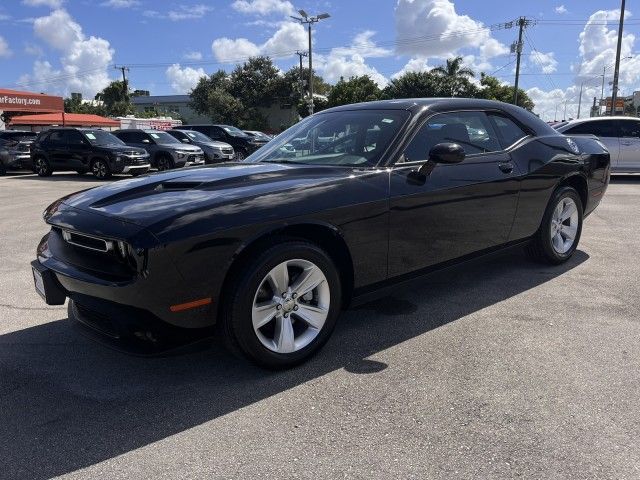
[0, 174, 640, 479]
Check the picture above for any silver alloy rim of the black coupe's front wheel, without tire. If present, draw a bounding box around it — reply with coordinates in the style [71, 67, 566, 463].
[251, 259, 331, 354]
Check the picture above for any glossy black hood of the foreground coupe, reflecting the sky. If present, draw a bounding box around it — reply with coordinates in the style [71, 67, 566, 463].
[57, 163, 353, 234]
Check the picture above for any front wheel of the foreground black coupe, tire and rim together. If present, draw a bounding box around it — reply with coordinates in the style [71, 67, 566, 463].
[219, 240, 341, 369]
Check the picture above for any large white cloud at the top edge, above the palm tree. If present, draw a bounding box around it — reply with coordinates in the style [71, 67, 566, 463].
[395, 0, 508, 58]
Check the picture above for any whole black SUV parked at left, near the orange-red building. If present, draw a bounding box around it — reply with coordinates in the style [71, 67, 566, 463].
[31, 127, 149, 180]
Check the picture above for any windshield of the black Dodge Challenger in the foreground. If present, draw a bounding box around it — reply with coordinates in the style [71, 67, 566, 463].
[247, 110, 409, 166]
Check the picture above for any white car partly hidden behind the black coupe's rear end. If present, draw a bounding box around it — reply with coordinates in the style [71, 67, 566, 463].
[553, 117, 640, 173]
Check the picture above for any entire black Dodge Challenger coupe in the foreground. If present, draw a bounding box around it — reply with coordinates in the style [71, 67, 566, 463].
[32, 98, 609, 368]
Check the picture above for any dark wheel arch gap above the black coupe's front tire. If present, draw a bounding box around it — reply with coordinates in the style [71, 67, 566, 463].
[221, 222, 354, 318]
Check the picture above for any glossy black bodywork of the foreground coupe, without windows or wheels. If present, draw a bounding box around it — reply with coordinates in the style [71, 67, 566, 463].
[31, 99, 609, 350]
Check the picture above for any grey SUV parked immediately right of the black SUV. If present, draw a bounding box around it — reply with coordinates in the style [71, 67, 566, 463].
[114, 128, 204, 171]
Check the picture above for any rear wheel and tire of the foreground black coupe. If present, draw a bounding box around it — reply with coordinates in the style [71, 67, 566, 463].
[527, 187, 583, 265]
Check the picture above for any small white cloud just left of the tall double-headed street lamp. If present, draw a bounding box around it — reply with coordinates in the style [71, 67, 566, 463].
[211, 22, 307, 63]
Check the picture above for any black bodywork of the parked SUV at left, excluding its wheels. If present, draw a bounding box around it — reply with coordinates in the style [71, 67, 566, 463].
[31, 127, 149, 173]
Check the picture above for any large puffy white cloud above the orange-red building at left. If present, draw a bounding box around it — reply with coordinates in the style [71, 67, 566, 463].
[20, 10, 114, 97]
